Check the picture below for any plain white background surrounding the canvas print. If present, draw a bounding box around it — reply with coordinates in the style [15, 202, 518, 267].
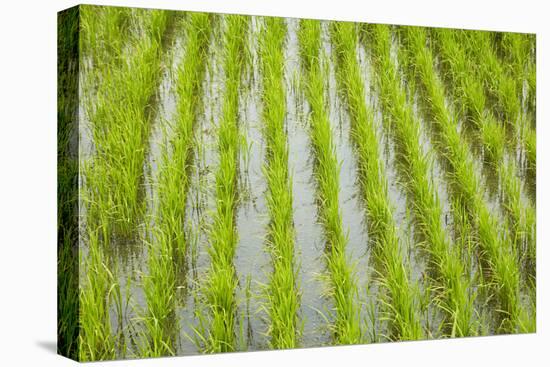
[0, 0, 550, 367]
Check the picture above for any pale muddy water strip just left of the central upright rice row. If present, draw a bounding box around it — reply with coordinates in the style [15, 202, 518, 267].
[234, 17, 271, 350]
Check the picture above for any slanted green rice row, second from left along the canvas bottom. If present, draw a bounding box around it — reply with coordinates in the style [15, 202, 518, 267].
[140, 13, 211, 356]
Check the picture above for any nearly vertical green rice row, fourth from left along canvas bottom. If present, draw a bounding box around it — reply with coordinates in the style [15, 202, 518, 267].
[259, 18, 301, 349]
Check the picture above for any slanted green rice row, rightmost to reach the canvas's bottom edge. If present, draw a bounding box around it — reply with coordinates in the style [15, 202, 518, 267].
[401, 27, 536, 331]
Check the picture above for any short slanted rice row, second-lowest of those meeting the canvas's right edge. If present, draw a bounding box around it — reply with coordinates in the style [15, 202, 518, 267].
[464, 31, 537, 176]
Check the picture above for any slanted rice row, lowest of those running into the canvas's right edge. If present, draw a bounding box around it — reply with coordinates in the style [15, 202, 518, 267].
[434, 29, 536, 274]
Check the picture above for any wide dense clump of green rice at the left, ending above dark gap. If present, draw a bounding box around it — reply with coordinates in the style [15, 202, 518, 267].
[86, 11, 168, 240]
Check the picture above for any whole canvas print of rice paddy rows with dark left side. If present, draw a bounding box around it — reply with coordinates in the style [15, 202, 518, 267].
[58, 5, 536, 361]
